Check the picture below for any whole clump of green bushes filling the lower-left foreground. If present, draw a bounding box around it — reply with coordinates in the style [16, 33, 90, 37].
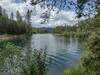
[0, 43, 48, 75]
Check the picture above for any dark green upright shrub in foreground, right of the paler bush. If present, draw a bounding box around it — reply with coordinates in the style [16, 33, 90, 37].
[21, 50, 47, 75]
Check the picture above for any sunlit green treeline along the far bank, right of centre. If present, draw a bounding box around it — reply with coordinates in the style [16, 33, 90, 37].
[54, 13, 100, 38]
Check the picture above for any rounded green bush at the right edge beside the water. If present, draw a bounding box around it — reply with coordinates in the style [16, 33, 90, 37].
[81, 33, 100, 75]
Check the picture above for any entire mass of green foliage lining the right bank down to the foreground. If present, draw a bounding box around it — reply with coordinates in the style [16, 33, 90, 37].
[65, 0, 100, 75]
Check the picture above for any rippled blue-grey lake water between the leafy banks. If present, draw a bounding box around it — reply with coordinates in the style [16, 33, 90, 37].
[26, 34, 80, 75]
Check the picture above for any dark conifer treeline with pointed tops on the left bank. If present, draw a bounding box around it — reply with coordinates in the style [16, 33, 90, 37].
[0, 7, 32, 35]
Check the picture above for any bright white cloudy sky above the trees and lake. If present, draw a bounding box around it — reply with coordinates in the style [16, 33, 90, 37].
[0, 0, 77, 27]
